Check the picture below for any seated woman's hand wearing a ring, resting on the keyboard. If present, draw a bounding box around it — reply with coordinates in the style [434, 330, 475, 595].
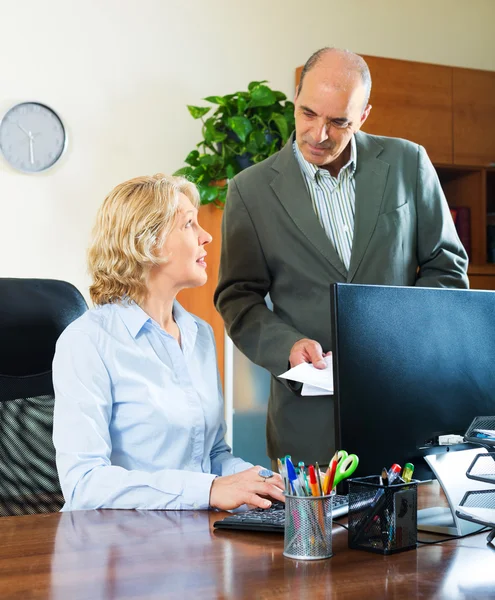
[210, 466, 285, 510]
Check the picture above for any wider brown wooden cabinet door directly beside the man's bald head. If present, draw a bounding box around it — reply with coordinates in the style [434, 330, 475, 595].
[363, 56, 453, 164]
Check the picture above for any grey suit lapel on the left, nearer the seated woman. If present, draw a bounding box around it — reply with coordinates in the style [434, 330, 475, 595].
[270, 135, 346, 277]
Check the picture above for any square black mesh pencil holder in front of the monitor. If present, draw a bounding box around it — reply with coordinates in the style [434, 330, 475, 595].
[348, 475, 418, 554]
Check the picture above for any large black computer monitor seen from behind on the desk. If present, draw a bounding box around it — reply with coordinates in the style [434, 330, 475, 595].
[331, 284, 495, 479]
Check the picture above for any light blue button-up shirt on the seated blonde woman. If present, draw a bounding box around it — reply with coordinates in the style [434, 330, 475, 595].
[53, 302, 252, 510]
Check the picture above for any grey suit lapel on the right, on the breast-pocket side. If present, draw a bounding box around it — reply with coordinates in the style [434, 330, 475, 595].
[347, 132, 390, 283]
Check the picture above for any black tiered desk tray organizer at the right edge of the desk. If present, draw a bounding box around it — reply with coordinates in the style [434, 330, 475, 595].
[456, 417, 495, 543]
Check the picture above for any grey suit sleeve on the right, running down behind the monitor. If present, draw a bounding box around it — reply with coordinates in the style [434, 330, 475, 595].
[416, 146, 469, 288]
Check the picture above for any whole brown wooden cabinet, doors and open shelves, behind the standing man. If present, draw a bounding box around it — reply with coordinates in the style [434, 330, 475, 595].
[296, 55, 495, 290]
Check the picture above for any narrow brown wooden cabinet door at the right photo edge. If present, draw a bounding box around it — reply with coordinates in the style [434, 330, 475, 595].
[453, 69, 495, 166]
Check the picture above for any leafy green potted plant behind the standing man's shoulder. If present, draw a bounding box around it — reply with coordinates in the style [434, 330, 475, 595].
[175, 81, 294, 207]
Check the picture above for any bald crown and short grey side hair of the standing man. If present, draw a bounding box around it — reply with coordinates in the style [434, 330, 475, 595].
[297, 48, 371, 109]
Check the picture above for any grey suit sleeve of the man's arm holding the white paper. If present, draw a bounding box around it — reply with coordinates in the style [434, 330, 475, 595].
[215, 180, 306, 382]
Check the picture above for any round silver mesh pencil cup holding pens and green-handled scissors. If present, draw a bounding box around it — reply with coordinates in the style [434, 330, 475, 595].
[284, 495, 332, 560]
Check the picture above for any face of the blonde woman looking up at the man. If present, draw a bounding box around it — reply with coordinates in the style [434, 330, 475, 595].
[159, 194, 212, 289]
